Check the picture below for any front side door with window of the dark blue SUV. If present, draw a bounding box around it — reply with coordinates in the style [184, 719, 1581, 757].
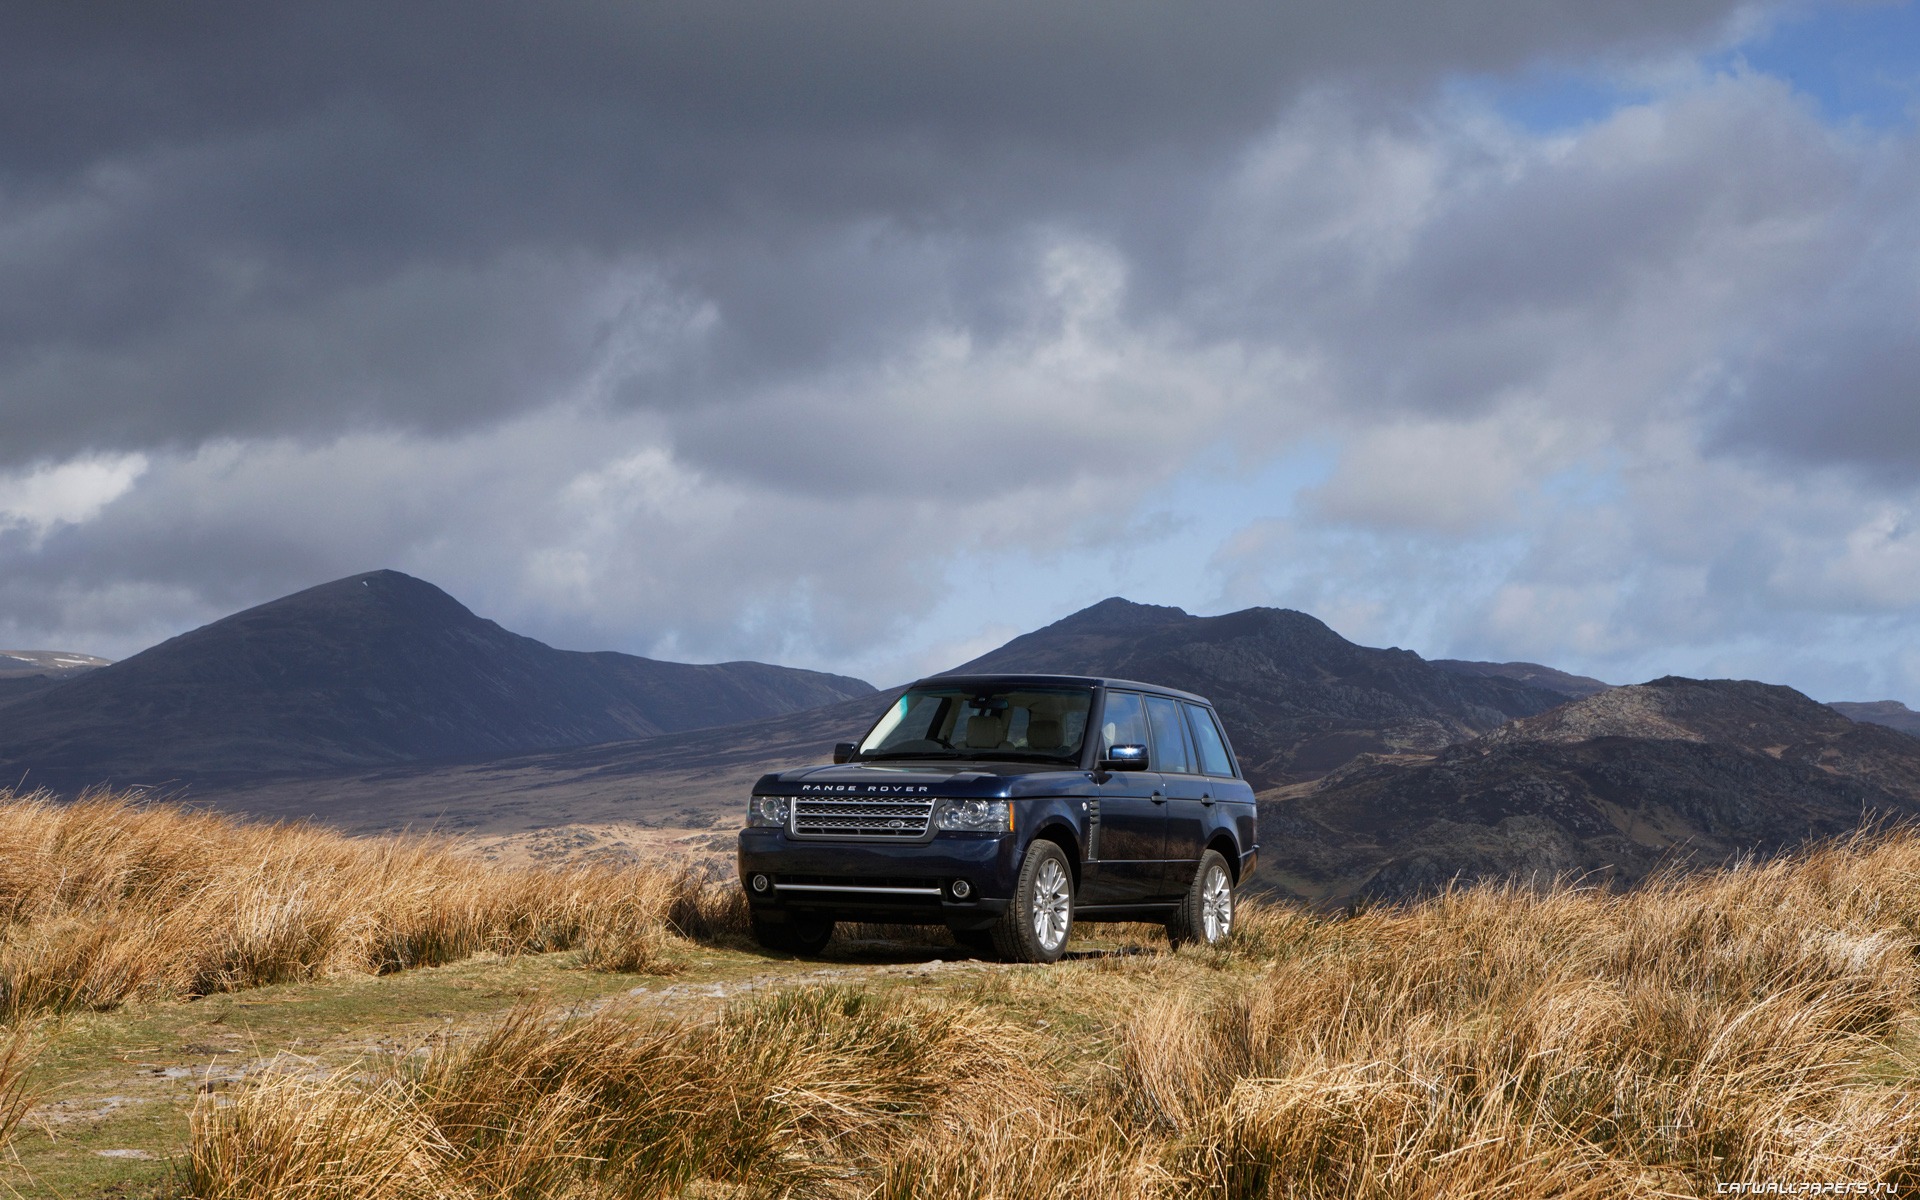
[1081, 691, 1167, 908]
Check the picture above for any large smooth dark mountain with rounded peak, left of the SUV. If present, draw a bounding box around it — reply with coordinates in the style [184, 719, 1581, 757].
[0, 570, 874, 789]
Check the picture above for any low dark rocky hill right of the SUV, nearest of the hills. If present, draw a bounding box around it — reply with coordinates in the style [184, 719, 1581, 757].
[1260, 678, 1920, 904]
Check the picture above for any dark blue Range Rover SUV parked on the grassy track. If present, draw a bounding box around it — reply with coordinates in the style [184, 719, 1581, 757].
[739, 676, 1260, 962]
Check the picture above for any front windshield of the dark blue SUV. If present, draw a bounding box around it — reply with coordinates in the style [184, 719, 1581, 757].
[860, 685, 1092, 762]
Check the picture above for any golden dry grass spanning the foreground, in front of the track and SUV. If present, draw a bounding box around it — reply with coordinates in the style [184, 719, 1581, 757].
[192, 831, 1920, 1200]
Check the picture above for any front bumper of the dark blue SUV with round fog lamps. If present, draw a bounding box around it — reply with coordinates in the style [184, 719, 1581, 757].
[739, 828, 1018, 929]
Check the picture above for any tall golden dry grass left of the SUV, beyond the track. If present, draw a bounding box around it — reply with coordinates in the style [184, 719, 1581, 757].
[0, 791, 745, 1021]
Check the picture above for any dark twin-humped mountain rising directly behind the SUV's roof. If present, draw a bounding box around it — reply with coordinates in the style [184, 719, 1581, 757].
[954, 597, 1569, 787]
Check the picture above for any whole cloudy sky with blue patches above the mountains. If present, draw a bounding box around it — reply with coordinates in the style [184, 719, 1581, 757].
[0, 0, 1920, 707]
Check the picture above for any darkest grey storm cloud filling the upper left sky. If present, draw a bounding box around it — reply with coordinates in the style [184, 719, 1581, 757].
[0, 0, 1758, 463]
